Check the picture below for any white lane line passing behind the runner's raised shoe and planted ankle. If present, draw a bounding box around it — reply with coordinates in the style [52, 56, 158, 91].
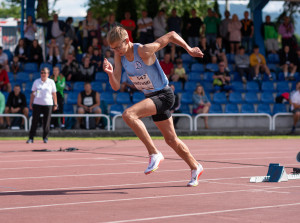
[0, 166, 262, 181]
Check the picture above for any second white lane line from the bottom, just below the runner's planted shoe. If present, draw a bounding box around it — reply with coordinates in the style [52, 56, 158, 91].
[0, 188, 300, 211]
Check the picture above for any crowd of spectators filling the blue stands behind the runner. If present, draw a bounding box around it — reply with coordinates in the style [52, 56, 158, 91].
[0, 9, 300, 131]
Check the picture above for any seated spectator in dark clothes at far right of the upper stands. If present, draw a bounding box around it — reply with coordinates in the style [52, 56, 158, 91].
[279, 45, 297, 80]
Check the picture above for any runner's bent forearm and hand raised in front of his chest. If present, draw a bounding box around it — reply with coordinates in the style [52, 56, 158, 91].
[103, 54, 122, 91]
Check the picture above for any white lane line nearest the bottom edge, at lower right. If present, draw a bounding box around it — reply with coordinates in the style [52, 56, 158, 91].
[106, 203, 300, 223]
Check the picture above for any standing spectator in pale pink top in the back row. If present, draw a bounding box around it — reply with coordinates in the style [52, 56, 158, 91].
[228, 14, 242, 54]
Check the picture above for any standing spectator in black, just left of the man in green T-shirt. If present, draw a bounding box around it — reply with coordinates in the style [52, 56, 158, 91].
[186, 9, 203, 47]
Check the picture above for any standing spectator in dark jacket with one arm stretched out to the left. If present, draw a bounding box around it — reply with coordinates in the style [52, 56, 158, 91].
[37, 14, 67, 55]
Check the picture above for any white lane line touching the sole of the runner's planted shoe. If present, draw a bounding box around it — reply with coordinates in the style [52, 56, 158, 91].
[0, 176, 253, 193]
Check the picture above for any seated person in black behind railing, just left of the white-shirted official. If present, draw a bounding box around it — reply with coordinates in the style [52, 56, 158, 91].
[5, 85, 29, 129]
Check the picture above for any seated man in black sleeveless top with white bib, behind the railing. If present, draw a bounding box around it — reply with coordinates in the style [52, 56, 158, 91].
[76, 82, 103, 128]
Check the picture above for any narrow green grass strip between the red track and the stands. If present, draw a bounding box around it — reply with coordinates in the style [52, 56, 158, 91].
[0, 135, 300, 141]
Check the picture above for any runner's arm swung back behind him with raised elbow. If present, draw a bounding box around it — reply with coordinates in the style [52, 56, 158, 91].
[138, 31, 204, 58]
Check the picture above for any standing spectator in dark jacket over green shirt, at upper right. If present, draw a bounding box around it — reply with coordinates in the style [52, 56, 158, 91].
[261, 15, 279, 54]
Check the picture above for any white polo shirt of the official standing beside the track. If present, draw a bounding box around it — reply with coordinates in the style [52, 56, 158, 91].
[31, 78, 56, 105]
